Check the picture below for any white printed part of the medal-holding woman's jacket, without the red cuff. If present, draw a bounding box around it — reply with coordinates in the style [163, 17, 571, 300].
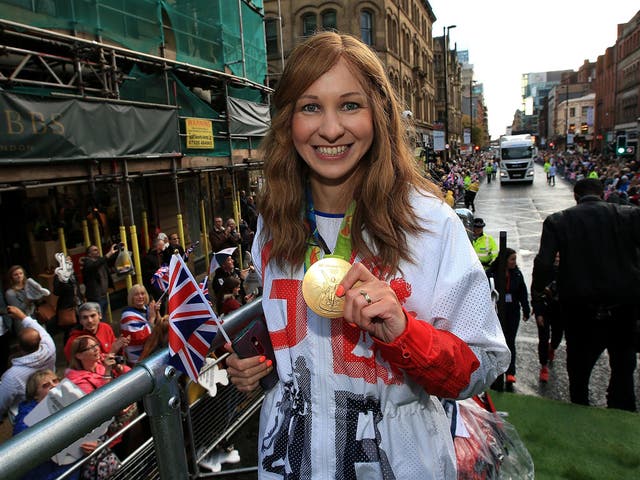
[253, 194, 510, 480]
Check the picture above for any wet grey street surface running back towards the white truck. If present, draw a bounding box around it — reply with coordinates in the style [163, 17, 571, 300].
[475, 165, 640, 410]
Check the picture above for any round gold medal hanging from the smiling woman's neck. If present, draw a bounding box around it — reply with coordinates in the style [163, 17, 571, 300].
[302, 257, 351, 318]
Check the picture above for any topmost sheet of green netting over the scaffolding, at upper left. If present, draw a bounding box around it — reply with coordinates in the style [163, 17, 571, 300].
[0, 0, 267, 84]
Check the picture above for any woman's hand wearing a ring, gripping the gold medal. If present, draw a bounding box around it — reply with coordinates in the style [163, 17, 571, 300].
[336, 263, 407, 343]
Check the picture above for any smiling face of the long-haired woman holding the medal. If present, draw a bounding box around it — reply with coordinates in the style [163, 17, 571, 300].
[291, 59, 374, 188]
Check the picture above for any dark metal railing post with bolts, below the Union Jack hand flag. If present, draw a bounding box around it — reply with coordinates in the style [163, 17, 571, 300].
[143, 365, 189, 480]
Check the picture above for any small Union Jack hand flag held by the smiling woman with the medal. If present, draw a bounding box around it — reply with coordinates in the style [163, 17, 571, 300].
[169, 255, 230, 382]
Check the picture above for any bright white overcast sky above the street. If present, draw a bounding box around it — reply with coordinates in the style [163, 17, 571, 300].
[429, 0, 640, 138]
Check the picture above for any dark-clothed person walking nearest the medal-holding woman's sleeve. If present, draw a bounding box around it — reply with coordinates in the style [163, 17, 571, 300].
[489, 248, 531, 385]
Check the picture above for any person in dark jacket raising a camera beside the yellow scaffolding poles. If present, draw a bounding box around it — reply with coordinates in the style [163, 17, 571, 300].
[80, 243, 118, 312]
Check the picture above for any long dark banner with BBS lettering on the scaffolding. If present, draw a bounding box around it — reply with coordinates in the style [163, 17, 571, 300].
[0, 92, 180, 162]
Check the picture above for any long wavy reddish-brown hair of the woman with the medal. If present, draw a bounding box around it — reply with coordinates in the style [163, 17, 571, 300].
[259, 32, 441, 273]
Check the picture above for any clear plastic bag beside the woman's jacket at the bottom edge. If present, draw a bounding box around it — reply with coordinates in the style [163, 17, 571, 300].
[453, 399, 535, 480]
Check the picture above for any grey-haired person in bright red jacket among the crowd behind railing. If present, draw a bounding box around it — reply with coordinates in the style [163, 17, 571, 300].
[64, 302, 129, 362]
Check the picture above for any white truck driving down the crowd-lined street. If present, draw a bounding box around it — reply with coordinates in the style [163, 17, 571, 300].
[500, 134, 536, 184]
